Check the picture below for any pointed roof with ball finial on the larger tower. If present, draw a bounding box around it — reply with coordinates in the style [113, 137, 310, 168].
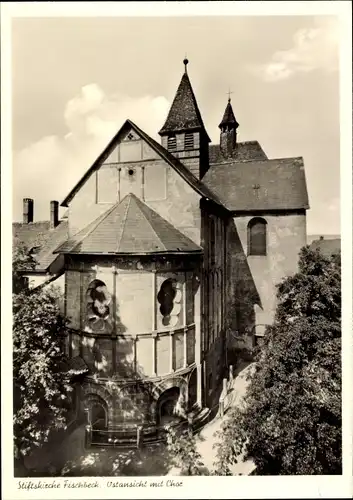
[159, 59, 210, 141]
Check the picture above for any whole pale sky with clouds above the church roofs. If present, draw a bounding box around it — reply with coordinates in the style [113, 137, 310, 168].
[12, 16, 340, 234]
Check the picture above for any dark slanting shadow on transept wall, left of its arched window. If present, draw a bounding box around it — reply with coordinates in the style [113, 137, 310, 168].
[226, 218, 262, 364]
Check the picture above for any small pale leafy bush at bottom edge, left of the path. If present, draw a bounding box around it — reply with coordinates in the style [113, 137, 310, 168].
[167, 427, 205, 476]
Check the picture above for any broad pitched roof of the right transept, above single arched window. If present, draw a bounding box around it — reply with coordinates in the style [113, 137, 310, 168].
[202, 157, 309, 211]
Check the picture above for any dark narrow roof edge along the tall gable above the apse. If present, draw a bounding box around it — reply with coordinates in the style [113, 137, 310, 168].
[61, 120, 221, 207]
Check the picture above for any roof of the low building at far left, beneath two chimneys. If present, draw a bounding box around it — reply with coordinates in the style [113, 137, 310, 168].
[12, 220, 68, 272]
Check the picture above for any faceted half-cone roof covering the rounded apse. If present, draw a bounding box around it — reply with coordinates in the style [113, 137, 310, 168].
[55, 193, 202, 254]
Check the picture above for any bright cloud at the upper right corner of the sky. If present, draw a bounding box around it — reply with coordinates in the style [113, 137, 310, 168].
[250, 17, 339, 82]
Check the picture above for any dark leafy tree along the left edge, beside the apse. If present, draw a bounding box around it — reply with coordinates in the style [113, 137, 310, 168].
[13, 246, 71, 461]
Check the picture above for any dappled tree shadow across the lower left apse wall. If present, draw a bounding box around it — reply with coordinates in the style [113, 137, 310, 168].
[77, 280, 199, 428]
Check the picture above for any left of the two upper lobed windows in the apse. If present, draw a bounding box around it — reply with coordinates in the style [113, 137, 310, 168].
[85, 280, 112, 333]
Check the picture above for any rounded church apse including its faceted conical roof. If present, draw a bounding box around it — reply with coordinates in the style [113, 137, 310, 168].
[57, 194, 202, 444]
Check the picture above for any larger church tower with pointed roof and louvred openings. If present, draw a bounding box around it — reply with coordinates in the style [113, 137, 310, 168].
[159, 59, 211, 179]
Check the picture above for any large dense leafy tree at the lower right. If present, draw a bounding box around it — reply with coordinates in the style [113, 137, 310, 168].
[215, 247, 342, 475]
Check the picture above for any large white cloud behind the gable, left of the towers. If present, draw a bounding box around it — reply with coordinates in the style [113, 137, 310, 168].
[13, 83, 170, 220]
